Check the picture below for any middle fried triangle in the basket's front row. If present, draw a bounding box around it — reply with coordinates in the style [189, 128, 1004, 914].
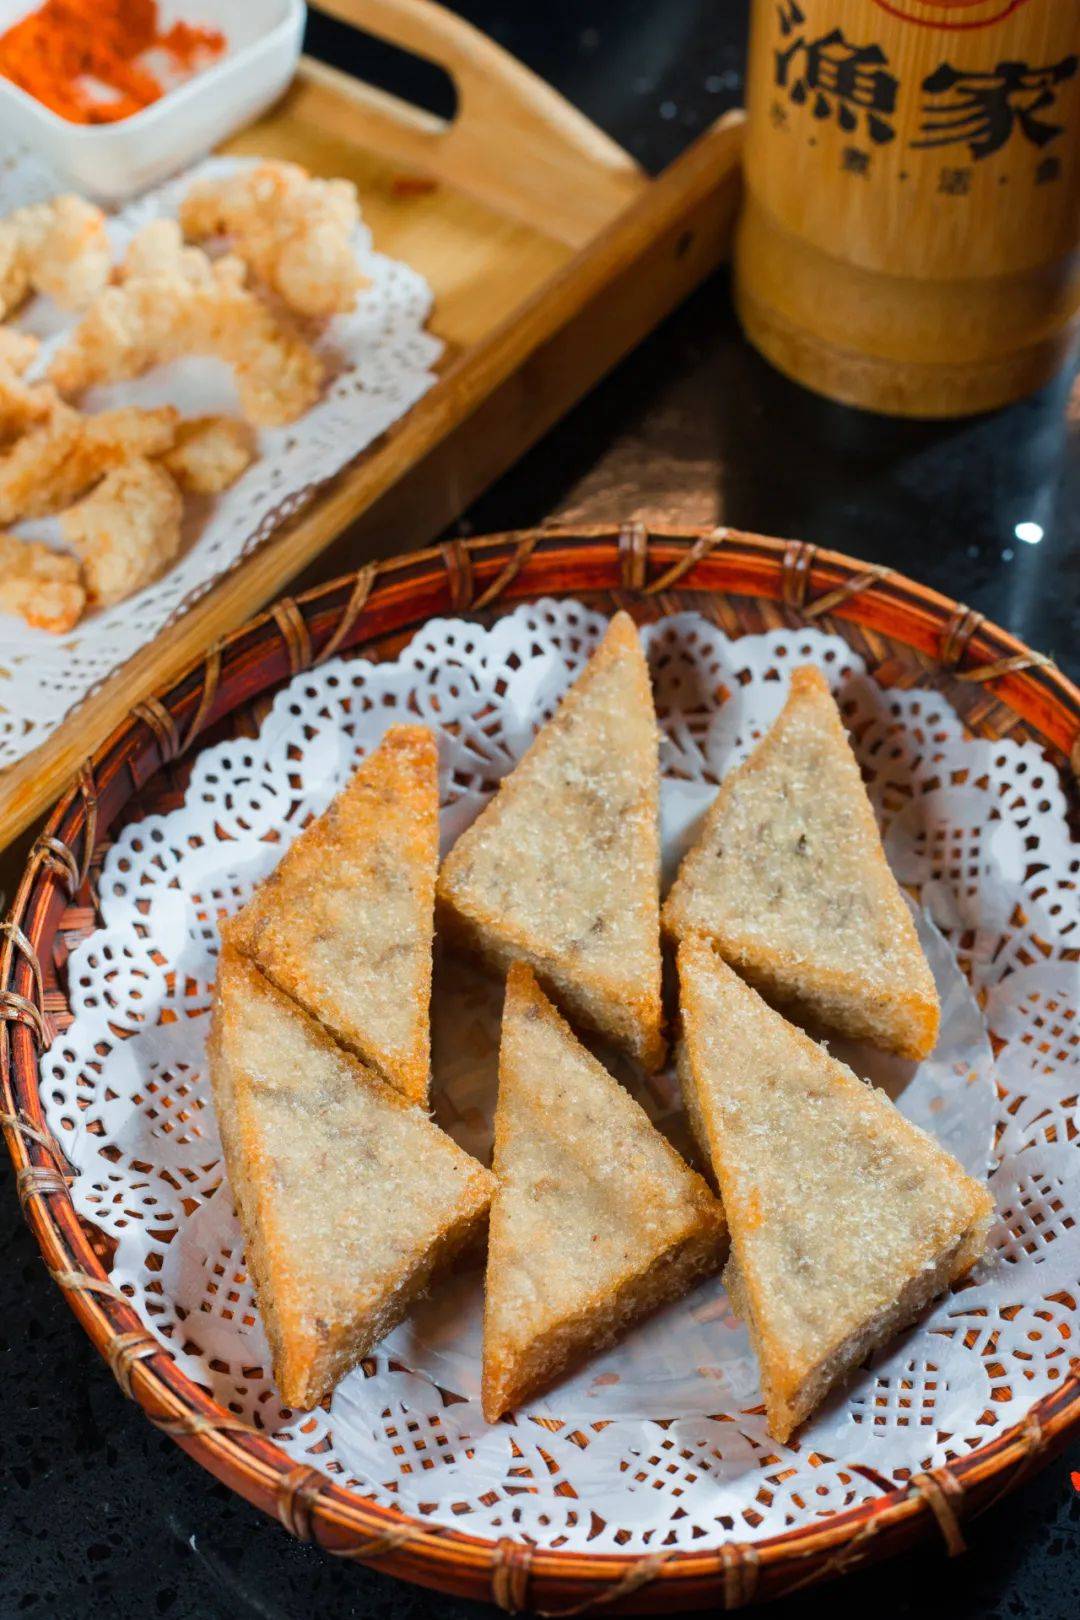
[483, 962, 727, 1422]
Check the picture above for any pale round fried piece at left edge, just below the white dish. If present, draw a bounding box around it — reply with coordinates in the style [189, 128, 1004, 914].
[0, 194, 112, 319]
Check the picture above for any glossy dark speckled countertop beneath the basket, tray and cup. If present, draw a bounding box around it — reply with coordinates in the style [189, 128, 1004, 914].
[0, 0, 1080, 1620]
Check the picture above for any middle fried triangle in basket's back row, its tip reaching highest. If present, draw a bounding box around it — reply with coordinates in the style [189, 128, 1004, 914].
[437, 614, 665, 1069]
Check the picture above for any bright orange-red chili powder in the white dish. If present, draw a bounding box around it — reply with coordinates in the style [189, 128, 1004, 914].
[0, 0, 225, 123]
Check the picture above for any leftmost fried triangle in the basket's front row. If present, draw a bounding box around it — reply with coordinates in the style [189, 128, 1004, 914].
[209, 944, 494, 1409]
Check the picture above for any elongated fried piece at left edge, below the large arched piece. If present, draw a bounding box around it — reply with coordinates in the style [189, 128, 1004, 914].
[0, 400, 180, 523]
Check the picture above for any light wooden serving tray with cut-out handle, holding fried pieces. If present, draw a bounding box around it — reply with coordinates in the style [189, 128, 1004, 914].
[0, 0, 742, 846]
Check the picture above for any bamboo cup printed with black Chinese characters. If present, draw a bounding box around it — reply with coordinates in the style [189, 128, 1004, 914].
[735, 0, 1080, 416]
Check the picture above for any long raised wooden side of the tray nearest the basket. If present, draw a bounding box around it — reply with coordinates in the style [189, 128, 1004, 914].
[0, 113, 742, 847]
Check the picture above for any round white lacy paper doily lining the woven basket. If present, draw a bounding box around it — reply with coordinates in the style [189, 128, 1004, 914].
[42, 601, 1080, 1552]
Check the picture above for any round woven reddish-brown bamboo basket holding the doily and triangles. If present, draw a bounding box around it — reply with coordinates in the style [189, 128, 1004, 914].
[0, 525, 1080, 1615]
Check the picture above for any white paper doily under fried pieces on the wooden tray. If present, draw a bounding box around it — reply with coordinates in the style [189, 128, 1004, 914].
[0, 154, 442, 770]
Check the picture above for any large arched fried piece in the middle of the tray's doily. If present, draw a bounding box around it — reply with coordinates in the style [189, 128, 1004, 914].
[50, 233, 324, 426]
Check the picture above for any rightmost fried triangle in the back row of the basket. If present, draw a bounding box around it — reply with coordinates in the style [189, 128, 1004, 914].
[662, 667, 941, 1059]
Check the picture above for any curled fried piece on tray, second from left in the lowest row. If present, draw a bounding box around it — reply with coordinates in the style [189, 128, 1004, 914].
[60, 457, 183, 608]
